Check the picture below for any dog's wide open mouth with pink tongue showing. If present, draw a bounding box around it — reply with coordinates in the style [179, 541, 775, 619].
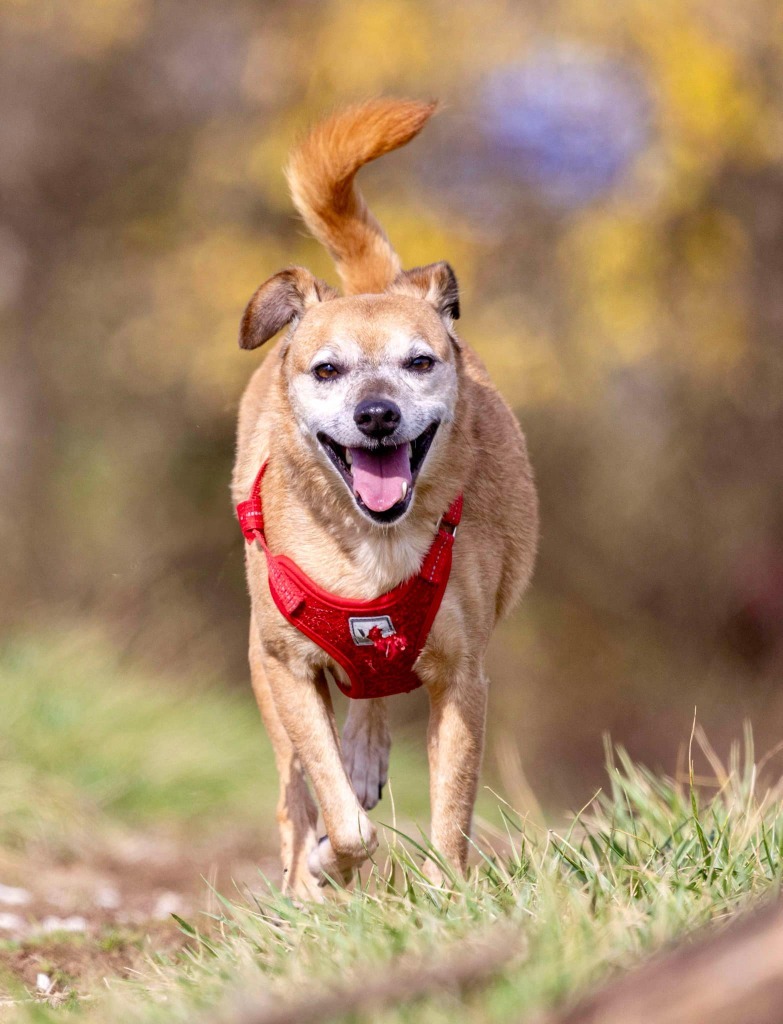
[318, 423, 438, 522]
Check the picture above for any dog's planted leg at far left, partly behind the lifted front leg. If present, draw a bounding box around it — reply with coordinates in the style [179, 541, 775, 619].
[250, 620, 320, 899]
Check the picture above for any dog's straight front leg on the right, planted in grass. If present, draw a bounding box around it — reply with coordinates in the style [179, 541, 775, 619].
[425, 665, 487, 882]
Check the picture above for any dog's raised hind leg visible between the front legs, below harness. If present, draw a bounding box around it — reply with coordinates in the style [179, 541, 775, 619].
[343, 698, 391, 811]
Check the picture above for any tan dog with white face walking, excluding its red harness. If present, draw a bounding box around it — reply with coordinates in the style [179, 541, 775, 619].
[232, 100, 537, 898]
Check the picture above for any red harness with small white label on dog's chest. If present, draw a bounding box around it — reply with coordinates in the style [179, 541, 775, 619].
[236, 463, 463, 698]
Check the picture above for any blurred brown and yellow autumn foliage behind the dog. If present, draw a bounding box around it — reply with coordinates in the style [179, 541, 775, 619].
[0, 0, 783, 812]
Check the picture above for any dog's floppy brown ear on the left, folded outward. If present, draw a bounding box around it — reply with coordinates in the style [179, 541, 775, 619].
[240, 266, 338, 348]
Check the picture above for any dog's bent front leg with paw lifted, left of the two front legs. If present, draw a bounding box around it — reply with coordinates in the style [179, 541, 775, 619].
[265, 657, 378, 885]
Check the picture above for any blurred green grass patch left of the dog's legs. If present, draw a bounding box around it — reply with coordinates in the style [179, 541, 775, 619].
[0, 634, 274, 848]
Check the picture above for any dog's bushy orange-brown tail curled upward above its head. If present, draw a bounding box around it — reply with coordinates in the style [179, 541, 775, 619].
[286, 99, 437, 295]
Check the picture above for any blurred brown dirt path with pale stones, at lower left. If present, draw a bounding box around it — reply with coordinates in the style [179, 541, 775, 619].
[0, 831, 277, 1007]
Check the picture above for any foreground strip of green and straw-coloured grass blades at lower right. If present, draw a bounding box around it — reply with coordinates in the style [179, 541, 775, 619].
[117, 733, 783, 1024]
